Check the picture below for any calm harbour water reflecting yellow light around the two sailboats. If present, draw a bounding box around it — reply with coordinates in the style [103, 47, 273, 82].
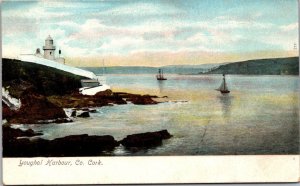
[21, 74, 299, 155]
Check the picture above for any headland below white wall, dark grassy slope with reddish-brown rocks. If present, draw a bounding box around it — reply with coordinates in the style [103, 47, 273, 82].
[2, 58, 158, 124]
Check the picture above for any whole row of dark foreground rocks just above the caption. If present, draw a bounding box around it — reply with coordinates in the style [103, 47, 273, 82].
[2, 125, 172, 157]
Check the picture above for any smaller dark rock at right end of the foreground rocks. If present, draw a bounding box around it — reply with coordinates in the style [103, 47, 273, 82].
[120, 130, 172, 148]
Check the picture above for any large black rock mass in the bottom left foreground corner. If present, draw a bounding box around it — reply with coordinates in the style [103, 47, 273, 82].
[3, 127, 119, 157]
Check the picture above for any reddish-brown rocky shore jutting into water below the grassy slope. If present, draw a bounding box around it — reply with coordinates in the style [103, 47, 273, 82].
[2, 88, 162, 124]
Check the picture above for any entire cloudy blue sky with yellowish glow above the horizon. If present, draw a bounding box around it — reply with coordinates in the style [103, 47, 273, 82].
[2, 0, 298, 66]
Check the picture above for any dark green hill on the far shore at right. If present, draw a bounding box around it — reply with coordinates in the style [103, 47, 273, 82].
[203, 57, 299, 75]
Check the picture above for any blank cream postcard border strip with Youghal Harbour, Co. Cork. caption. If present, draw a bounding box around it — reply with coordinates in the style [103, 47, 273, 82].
[3, 155, 299, 185]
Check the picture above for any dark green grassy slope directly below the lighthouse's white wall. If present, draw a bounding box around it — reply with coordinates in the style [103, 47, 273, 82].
[2, 58, 83, 98]
